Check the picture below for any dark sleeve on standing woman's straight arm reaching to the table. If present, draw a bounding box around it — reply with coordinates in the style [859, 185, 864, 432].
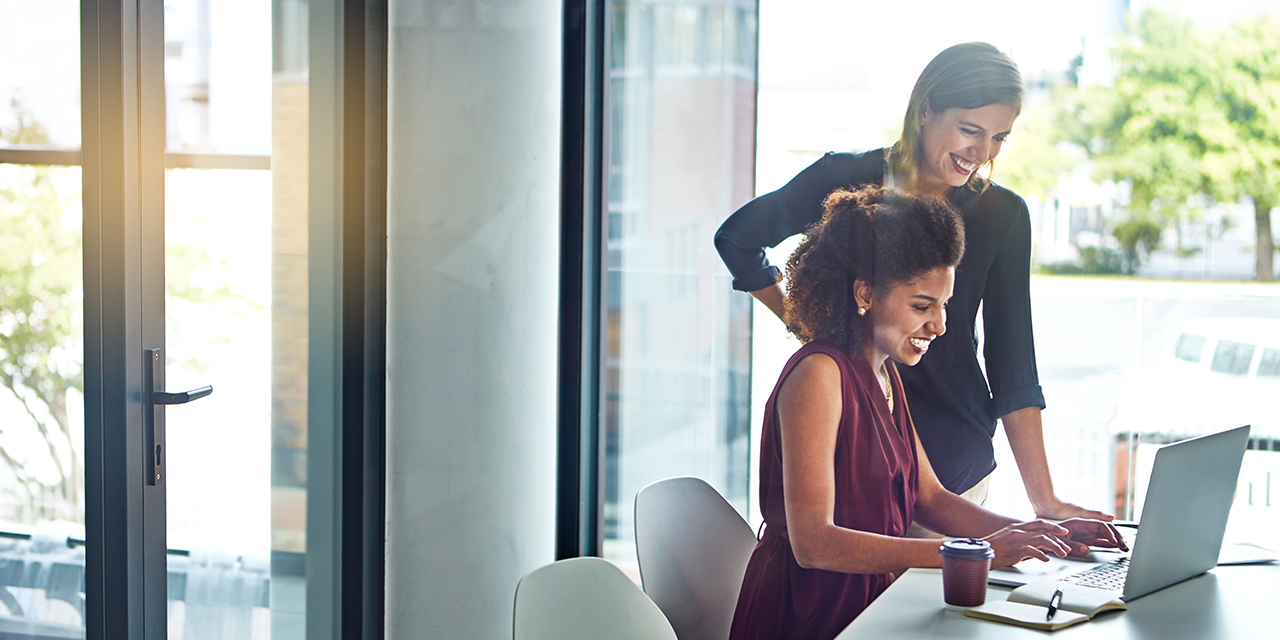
[982, 196, 1044, 417]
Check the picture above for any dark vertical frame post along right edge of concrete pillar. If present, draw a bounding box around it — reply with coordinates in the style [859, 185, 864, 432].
[556, 0, 608, 559]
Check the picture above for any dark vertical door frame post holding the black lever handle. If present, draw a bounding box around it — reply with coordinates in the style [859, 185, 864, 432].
[81, 0, 166, 637]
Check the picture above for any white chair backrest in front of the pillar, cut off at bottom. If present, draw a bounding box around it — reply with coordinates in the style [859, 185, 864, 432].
[515, 558, 676, 640]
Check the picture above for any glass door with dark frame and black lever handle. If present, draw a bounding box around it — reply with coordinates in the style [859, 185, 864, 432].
[78, 0, 385, 640]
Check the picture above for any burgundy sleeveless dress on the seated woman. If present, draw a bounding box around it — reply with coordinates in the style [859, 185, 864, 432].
[730, 343, 919, 640]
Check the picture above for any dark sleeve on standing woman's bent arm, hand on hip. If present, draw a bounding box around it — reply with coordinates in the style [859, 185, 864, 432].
[716, 152, 849, 292]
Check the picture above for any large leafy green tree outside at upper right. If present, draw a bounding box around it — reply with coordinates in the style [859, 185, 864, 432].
[1061, 10, 1280, 280]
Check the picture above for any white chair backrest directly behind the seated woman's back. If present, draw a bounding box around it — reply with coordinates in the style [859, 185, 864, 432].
[635, 477, 755, 640]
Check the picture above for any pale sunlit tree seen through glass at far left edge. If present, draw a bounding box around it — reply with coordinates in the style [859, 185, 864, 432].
[0, 102, 84, 521]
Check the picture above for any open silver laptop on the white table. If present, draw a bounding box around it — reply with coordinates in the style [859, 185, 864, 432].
[989, 426, 1249, 602]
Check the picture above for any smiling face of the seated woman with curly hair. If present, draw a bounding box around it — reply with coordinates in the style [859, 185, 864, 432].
[867, 266, 956, 366]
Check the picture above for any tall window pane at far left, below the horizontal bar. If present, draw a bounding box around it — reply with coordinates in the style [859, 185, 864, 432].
[0, 163, 84, 635]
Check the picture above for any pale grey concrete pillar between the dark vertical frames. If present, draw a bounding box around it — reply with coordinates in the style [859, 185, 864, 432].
[387, 0, 562, 640]
